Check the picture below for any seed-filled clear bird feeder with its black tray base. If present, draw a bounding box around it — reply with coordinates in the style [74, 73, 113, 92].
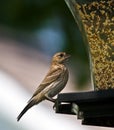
[56, 0, 114, 127]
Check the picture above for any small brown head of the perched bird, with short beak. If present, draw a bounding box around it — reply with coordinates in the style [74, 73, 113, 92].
[52, 52, 70, 64]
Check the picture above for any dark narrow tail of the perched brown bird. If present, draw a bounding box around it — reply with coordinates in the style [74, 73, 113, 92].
[17, 100, 36, 121]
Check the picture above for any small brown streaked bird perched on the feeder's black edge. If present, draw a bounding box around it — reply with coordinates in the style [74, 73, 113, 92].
[17, 52, 70, 121]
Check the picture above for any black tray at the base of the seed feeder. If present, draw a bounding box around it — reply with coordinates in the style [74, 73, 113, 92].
[55, 89, 114, 127]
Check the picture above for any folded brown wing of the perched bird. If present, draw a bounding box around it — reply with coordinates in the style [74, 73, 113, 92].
[29, 68, 63, 98]
